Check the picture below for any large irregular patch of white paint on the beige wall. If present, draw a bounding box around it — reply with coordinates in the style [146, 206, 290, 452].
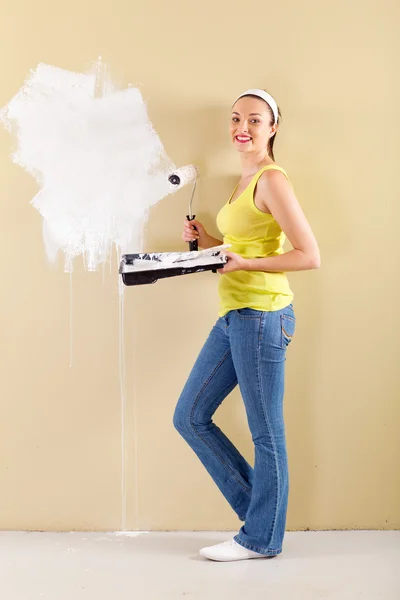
[0, 63, 192, 271]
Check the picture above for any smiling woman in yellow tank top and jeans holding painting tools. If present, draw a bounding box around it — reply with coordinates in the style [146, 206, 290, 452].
[174, 89, 320, 561]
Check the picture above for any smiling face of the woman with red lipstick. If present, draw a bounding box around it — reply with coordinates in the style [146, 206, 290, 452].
[230, 96, 276, 152]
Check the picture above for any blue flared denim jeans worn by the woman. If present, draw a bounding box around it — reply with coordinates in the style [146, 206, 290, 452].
[174, 304, 295, 556]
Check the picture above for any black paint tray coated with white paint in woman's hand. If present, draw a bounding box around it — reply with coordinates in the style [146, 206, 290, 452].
[119, 246, 228, 285]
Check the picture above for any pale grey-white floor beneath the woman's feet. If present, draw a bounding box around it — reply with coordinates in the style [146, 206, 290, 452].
[0, 531, 400, 600]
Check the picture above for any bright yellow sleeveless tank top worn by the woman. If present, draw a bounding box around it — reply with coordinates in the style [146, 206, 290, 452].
[217, 165, 293, 317]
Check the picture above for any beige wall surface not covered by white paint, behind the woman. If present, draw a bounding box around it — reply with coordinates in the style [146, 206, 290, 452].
[0, 0, 400, 530]
